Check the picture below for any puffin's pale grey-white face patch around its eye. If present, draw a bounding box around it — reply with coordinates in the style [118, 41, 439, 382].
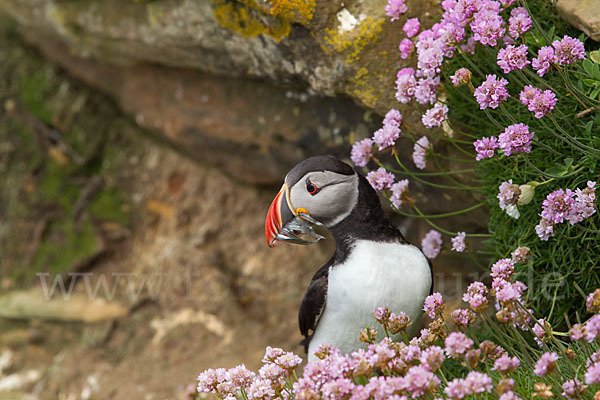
[290, 171, 358, 227]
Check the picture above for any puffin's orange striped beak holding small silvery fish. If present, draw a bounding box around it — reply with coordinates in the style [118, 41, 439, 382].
[265, 183, 324, 247]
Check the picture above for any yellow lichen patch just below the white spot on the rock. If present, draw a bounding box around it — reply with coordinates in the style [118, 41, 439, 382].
[324, 17, 385, 62]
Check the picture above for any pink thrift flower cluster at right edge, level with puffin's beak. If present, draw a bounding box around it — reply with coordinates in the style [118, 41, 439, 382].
[535, 181, 596, 240]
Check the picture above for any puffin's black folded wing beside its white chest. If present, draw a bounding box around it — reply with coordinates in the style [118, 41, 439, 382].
[298, 257, 334, 353]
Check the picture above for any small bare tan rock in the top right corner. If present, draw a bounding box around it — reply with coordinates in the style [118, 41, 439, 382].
[556, 0, 600, 42]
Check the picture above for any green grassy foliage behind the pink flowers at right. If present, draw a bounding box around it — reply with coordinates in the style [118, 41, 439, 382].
[444, 1, 600, 323]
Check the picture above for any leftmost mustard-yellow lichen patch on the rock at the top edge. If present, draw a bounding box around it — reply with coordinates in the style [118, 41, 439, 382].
[213, 0, 291, 40]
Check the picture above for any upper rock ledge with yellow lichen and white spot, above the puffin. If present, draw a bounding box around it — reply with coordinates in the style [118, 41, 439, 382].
[0, 0, 433, 112]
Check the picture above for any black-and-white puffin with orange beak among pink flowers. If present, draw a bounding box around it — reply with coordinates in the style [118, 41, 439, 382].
[265, 156, 433, 362]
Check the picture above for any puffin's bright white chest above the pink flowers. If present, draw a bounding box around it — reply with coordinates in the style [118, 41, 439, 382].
[309, 241, 431, 360]
